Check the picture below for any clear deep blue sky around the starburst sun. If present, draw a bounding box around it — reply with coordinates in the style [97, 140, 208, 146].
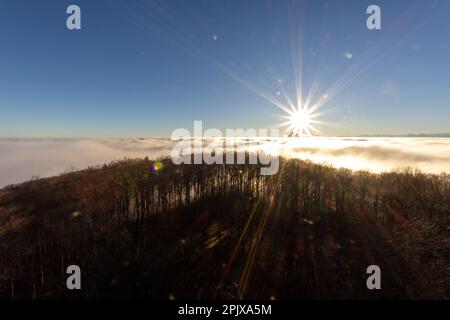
[0, 0, 450, 137]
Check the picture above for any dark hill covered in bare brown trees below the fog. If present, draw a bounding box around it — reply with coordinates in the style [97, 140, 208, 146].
[0, 159, 450, 299]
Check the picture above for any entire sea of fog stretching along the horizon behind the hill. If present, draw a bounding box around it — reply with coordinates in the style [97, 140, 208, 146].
[0, 137, 450, 187]
